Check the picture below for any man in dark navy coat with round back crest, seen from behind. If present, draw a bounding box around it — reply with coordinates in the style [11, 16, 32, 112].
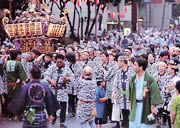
[8, 67, 58, 128]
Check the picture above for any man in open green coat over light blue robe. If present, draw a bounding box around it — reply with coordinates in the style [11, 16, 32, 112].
[128, 57, 162, 128]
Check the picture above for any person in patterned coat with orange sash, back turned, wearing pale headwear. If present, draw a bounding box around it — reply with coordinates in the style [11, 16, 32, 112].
[77, 66, 97, 128]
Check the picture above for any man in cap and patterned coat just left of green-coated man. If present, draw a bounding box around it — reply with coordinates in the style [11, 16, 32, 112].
[112, 55, 134, 128]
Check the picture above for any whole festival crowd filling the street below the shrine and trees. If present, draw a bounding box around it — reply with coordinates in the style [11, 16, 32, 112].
[0, 29, 180, 128]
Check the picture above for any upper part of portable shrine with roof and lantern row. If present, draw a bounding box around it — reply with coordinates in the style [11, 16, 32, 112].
[2, 0, 67, 39]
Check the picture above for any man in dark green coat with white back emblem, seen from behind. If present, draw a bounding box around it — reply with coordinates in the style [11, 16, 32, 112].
[4, 50, 27, 118]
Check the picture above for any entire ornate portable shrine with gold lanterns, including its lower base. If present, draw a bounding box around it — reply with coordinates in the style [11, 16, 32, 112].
[2, 0, 68, 52]
